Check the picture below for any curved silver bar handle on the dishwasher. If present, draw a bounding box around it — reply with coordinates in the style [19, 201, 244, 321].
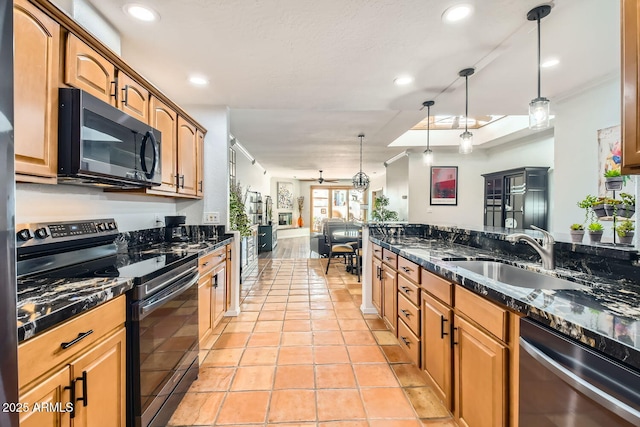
[520, 337, 640, 426]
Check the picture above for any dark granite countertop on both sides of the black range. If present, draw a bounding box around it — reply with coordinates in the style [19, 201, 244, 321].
[18, 235, 233, 342]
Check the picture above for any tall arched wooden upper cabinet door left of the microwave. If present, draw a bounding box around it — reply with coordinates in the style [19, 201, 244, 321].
[13, 0, 60, 183]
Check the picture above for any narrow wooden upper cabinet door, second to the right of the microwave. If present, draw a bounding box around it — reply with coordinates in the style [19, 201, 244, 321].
[178, 116, 198, 196]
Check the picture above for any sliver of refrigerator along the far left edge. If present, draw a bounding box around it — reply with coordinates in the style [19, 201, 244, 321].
[0, 0, 18, 427]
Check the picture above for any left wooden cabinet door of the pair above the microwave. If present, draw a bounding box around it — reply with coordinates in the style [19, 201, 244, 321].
[65, 33, 116, 106]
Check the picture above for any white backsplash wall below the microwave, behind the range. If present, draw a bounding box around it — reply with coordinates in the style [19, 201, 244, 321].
[16, 183, 176, 231]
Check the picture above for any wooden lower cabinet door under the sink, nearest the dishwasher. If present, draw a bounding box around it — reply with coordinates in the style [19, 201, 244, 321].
[453, 316, 508, 427]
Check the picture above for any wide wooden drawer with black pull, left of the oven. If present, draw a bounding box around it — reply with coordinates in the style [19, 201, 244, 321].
[18, 295, 126, 388]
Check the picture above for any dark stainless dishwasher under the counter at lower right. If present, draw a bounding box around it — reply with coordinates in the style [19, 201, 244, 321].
[519, 319, 640, 427]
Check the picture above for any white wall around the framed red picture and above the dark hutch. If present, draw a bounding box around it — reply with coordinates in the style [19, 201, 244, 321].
[409, 133, 554, 227]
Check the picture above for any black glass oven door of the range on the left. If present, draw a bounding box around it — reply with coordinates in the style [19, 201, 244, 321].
[129, 270, 198, 427]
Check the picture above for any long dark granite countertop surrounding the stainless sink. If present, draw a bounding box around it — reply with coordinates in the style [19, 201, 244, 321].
[370, 236, 640, 369]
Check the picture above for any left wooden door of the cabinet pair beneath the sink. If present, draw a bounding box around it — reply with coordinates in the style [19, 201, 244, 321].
[421, 292, 453, 411]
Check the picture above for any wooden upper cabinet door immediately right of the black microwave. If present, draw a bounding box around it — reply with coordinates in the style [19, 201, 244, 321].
[149, 96, 178, 193]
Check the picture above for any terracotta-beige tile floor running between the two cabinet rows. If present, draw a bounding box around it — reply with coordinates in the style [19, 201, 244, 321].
[169, 259, 456, 427]
